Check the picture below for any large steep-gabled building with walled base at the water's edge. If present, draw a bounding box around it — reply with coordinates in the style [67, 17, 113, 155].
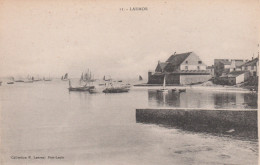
[148, 52, 211, 85]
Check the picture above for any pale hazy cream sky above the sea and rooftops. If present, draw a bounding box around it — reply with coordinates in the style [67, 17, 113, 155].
[0, 0, 259, 78]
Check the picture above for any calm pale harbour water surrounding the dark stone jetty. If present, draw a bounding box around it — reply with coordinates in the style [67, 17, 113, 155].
[0, 80, 258, 165]
